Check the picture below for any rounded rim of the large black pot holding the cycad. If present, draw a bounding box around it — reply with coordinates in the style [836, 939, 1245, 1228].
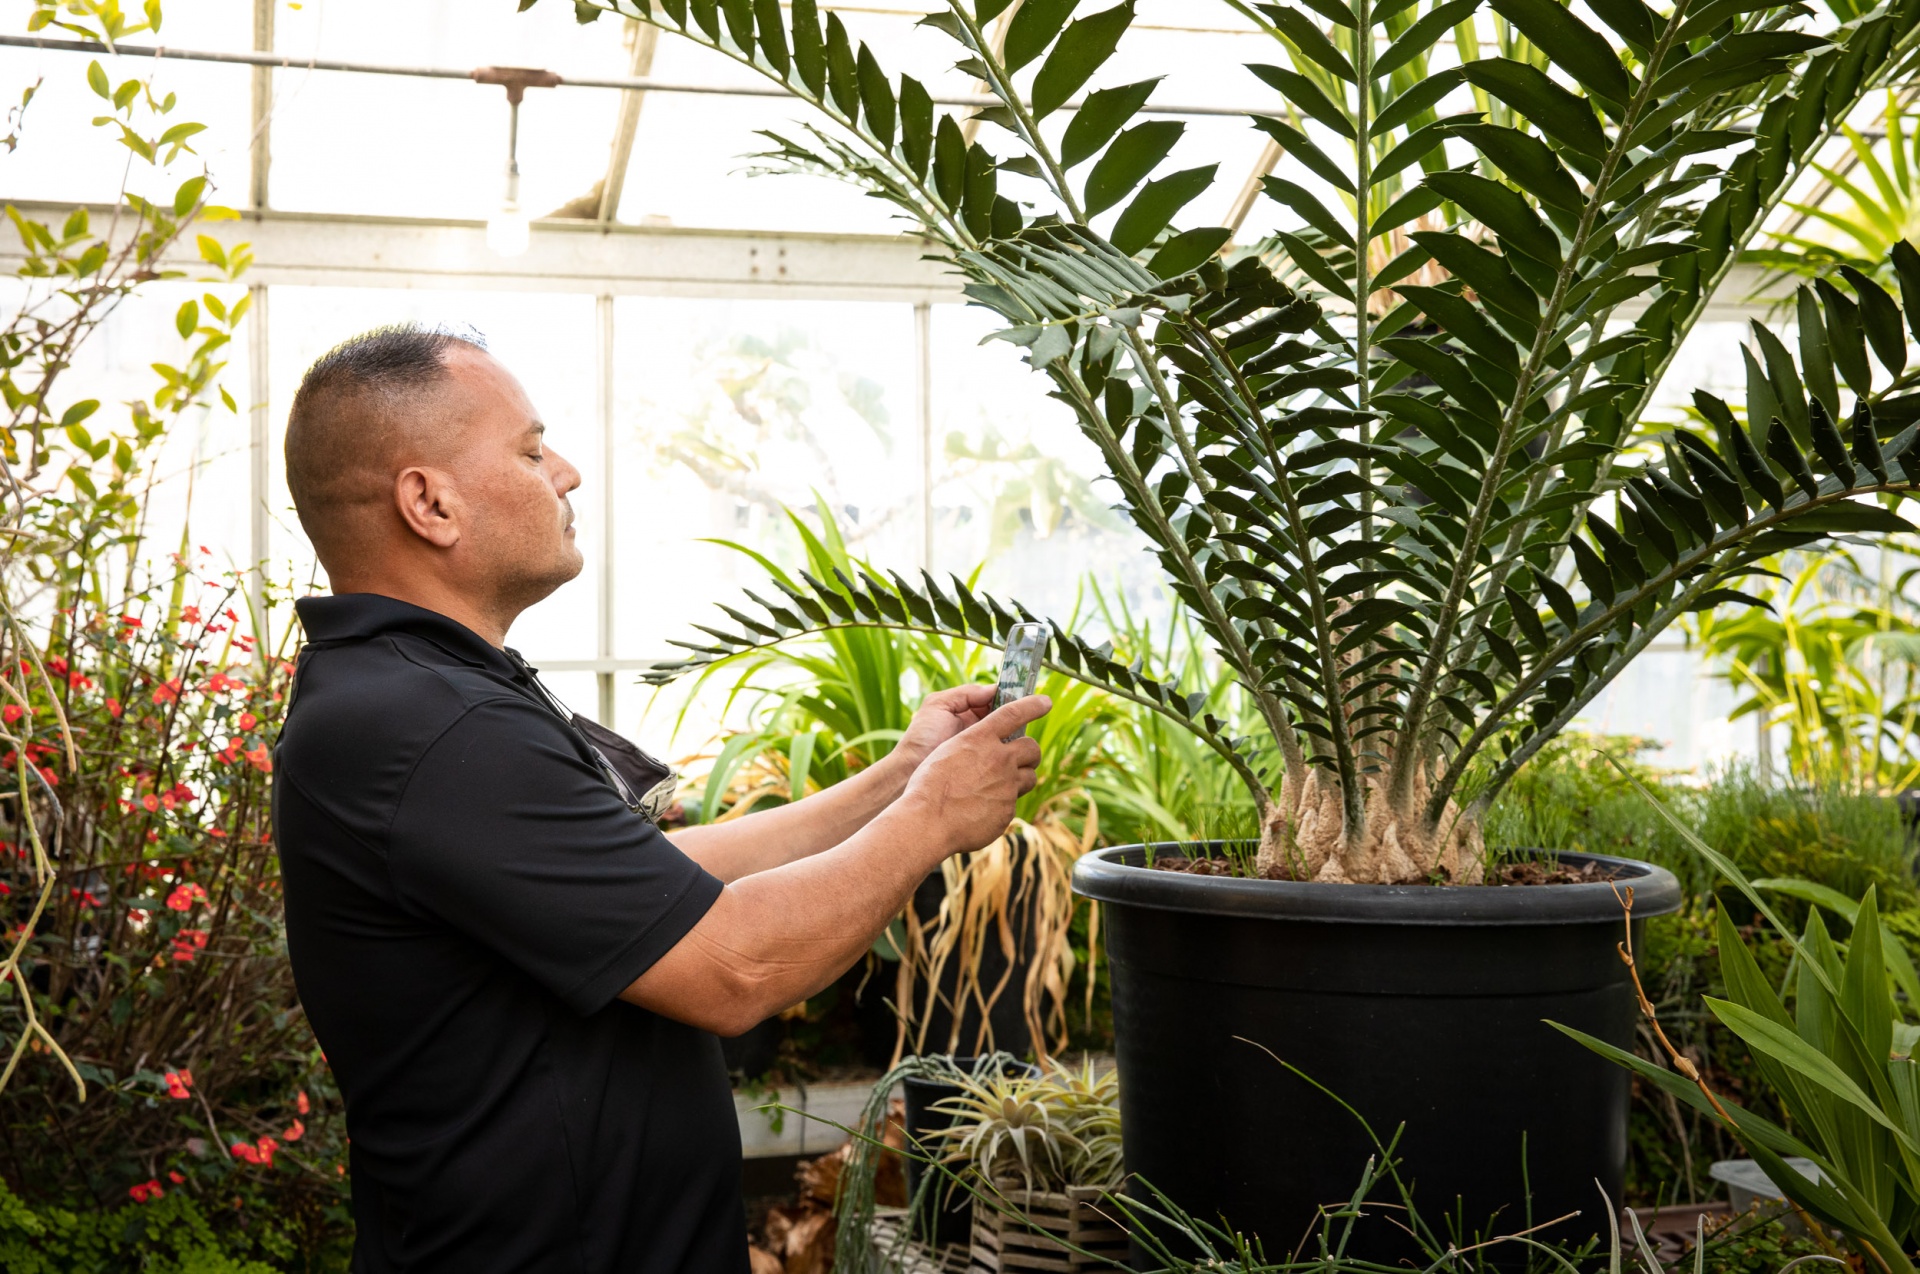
[1073, 840, 1682, 925]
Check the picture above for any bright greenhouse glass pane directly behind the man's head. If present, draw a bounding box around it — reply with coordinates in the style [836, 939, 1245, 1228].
[271, 288, 601, 664]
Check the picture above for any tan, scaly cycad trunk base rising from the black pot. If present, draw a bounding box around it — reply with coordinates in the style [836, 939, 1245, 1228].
[1256, 769, 1486, 885]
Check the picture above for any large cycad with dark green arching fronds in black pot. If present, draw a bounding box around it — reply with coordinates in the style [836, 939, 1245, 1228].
[549, 0, 1920, 883]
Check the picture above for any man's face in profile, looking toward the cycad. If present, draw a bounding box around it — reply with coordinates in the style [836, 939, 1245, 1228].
[444, 345, 582, 606]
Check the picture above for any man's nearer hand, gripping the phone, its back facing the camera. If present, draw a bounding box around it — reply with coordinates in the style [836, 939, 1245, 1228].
[900, 698, 1054, 854]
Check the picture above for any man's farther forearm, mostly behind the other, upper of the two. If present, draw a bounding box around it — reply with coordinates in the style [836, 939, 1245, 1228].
[668, 756, 912, 883]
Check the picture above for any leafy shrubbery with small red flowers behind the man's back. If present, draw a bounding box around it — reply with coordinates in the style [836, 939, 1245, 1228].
[0, 0, 349, 1270]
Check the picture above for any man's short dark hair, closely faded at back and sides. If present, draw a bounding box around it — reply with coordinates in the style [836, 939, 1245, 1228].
[286, 322, 486, 547]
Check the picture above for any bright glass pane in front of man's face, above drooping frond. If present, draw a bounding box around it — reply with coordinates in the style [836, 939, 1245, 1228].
[614, 297, 920, 658]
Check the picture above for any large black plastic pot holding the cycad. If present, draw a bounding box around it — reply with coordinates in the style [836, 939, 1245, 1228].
[1073, 846, 1680, 1261]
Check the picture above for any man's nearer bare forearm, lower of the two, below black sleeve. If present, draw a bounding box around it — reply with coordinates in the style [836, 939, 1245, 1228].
[622, 802, 945, 1034]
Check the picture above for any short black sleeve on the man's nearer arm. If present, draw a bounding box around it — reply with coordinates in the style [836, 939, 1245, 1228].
[388, 700, 722, 1015]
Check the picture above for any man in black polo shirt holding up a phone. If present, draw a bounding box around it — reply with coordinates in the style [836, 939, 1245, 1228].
[275, 328, 1048, 1274]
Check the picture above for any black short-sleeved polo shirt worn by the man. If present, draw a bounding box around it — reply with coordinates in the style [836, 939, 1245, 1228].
[273, 593, 747, 1274]
